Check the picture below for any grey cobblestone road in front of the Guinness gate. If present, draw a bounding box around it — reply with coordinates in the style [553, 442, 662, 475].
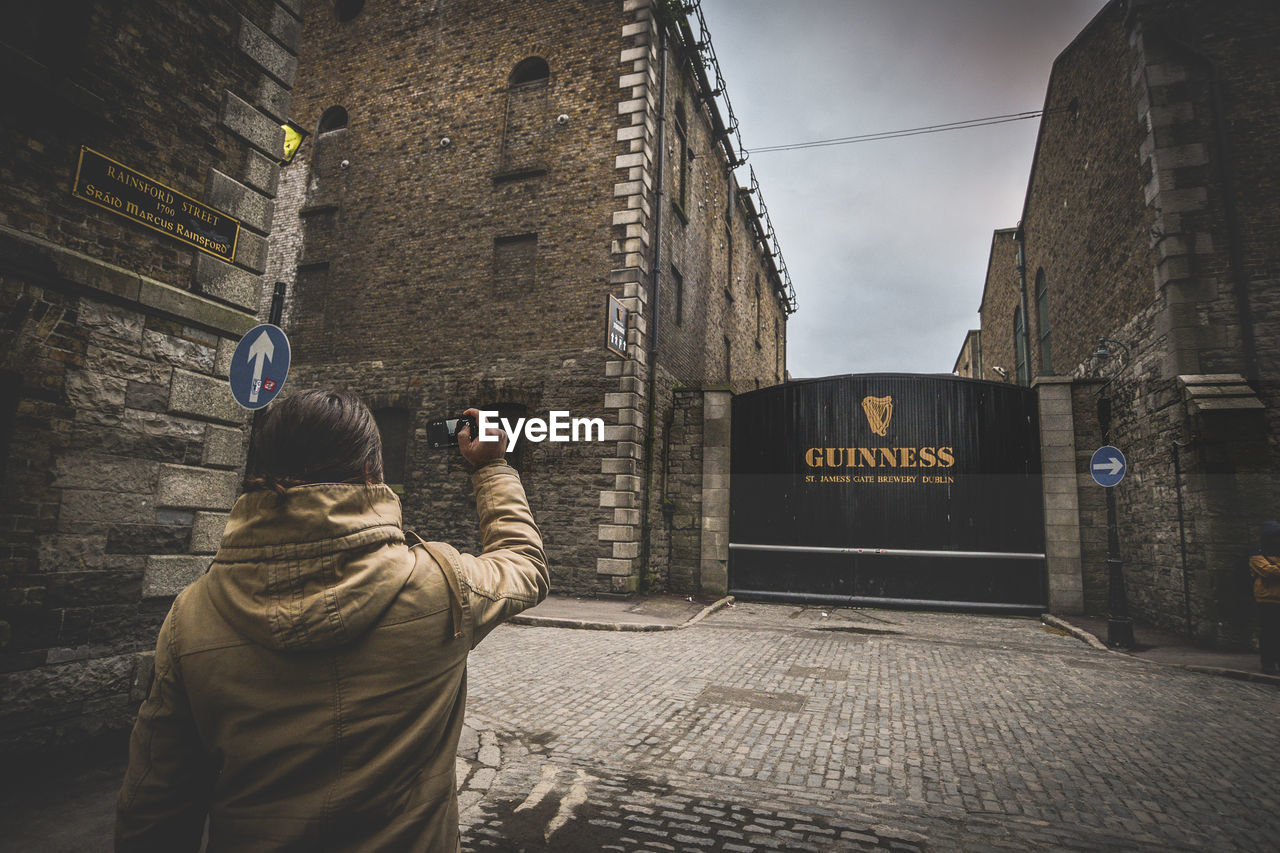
[458, 603, 1280, 852]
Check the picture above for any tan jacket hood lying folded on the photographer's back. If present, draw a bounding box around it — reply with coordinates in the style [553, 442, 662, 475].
[205, 483, 413, 651]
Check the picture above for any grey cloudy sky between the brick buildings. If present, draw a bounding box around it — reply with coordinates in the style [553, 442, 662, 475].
[701, 0, 1105, 378]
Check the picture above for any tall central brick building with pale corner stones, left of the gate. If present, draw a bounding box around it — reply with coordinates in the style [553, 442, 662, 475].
[268, 0, 794, 593]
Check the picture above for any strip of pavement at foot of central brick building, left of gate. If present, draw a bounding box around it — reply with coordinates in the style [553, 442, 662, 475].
[511, 594, 733, 631]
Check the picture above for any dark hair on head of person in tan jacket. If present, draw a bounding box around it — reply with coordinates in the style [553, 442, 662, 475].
[244, 391, 383, 494]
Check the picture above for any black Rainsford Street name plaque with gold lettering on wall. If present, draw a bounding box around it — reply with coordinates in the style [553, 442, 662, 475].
[72, 146, 239, 261]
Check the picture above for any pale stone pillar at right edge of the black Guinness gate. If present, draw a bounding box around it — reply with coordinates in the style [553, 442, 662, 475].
[1032, 377, 1084, 613]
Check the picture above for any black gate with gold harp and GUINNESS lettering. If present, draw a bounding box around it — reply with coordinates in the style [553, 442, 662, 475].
[728, 374, 1047, 612]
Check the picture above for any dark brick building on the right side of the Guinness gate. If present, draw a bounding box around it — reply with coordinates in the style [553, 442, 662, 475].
[980, 0, 1280, 646]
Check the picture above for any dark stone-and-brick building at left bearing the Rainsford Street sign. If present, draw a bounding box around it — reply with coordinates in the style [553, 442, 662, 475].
[0, 0, 301, 753]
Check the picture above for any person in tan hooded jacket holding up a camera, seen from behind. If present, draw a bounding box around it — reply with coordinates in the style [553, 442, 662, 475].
[115, 391, 548, 853]
